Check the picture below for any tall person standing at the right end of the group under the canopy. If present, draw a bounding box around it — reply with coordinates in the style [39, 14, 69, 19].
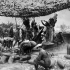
[41, 14, 57, 42]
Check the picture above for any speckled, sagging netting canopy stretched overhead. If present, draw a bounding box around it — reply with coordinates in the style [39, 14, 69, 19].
[0, 0, 67, 17]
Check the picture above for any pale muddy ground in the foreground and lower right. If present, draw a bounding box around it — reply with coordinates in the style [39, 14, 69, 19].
[0, 43, 70, 70]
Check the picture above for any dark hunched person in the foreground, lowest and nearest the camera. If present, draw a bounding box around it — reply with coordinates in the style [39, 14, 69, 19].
[34, 44, 52, 70]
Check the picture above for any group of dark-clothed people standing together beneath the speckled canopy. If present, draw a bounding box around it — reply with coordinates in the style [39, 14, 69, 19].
[9, 14, 57, 46]
